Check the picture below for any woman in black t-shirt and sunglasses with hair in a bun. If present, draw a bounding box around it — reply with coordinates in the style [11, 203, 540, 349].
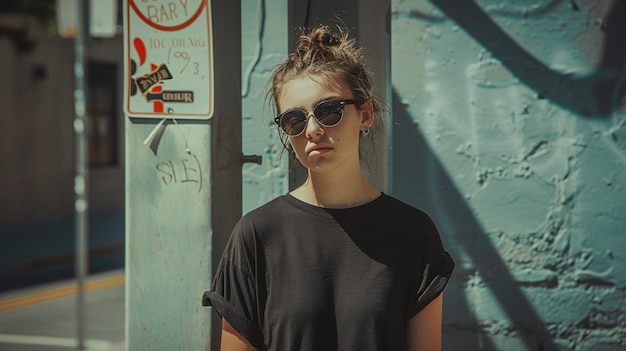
[204, 26, 454, 351]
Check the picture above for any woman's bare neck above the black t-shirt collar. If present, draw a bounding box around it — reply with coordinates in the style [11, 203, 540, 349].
[291, 169, 380, 208]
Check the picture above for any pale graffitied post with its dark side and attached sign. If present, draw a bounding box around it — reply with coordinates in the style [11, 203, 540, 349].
[124, 0, 241, 350]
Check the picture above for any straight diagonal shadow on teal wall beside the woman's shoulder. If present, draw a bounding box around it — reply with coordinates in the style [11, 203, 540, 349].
[392, 91, 557, 350]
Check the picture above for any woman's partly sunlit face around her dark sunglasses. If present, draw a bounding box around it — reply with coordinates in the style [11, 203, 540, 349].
[278, 77, 373, 176]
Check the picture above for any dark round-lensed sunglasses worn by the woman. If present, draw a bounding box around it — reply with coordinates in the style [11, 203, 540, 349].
[274, 100, 357, 137]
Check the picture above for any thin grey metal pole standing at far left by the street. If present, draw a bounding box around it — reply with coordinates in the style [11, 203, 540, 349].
[74, 0, 89, 350]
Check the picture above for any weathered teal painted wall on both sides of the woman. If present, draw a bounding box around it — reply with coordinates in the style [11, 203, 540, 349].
[242, 0, 626, 350]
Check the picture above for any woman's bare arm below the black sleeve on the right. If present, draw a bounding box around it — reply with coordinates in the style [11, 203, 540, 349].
[407, 294, 443, 351]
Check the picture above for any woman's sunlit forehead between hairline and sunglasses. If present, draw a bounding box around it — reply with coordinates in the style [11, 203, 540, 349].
[277, 76, 352, 112]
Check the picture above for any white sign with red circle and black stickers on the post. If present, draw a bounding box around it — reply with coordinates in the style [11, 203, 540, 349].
[124, 0, 214, 119]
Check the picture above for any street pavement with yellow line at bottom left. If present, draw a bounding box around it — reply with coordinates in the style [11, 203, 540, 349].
[0, 269, 125, 351]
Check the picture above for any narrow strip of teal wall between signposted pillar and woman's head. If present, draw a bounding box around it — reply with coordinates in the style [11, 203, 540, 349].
[241, 0, 292, 213]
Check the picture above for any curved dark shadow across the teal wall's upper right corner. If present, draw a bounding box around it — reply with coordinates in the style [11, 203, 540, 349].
[431, 0, 626, 118]
